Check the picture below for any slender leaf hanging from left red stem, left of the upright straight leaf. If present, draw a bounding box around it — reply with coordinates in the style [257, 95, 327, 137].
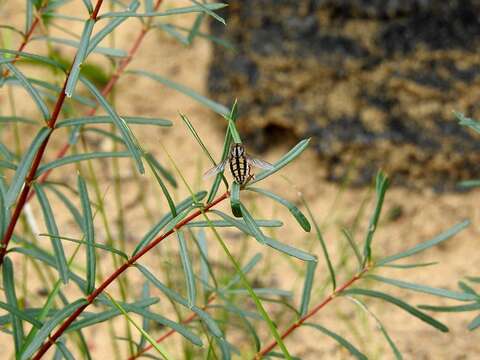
[33, 183, 68, 284]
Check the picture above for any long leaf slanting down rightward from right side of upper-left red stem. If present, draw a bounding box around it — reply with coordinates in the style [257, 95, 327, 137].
[80, 77, 145, 174]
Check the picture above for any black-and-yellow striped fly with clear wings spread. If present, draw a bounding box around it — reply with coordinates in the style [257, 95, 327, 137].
[204, 143, 274, 186]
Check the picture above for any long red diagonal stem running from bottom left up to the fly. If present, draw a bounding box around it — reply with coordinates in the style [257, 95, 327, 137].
[33, 191, 229, 360]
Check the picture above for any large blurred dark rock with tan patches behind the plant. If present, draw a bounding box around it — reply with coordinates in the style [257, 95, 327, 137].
[209, 0, 480, 190]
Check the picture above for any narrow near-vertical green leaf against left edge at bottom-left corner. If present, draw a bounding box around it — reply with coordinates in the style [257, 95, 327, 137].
[2, 257, 24, 354]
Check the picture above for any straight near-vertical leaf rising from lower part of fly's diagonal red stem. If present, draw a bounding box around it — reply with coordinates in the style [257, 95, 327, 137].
[77, 174, 97, 294]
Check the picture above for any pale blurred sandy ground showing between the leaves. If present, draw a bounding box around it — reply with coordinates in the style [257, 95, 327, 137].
[0, 1, 480, 359]
